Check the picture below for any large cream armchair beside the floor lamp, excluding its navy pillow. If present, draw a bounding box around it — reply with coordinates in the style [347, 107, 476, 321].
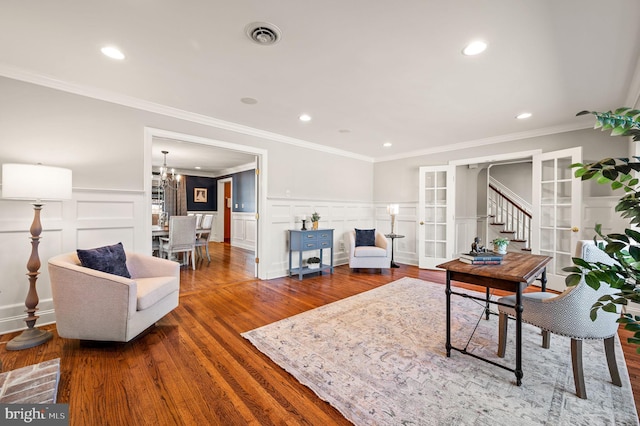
[48, 252, 180, 342]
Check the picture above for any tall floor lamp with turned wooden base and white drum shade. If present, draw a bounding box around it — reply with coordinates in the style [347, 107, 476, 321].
[2, 164, 71, 351]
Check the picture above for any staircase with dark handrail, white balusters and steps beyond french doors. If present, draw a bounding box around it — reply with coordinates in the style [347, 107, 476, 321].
[487, 180, 531, 252]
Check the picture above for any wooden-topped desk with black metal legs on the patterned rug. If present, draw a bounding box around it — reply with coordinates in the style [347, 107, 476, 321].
[438, 253, 552, 386]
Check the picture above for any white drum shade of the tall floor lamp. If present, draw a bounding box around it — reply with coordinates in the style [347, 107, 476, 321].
[2, 164, 71, 200]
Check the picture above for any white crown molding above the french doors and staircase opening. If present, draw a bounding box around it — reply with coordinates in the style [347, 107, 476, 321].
[375, 123, 593, 163]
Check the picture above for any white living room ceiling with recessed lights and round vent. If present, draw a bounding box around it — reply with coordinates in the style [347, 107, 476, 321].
[0, 0, 640, 165]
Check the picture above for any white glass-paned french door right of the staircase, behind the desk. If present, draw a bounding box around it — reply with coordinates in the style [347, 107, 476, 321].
[531, 147, 582, 291]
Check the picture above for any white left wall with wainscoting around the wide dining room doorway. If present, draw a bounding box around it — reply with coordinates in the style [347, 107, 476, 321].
[0, 77, 373, 333]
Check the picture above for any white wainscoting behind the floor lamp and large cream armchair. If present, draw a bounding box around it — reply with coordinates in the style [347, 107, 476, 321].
[0, 189, 146, 334]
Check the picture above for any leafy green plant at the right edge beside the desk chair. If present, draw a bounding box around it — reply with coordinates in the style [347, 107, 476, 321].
[564, 108, 640, 353]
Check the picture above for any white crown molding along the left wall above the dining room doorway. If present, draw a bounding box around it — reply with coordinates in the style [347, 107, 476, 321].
[0, 65, 374, 163]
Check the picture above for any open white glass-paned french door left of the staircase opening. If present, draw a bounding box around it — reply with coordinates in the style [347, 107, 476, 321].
[418, 166, 456, 269]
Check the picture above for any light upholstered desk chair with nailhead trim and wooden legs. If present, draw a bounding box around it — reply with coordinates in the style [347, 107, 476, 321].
[498, 240, 622, 399]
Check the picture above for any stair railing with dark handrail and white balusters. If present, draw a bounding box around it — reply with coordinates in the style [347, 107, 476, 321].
[488, 183, 531, 248]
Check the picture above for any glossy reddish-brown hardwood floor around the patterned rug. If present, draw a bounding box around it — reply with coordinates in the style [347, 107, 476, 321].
[0, 243, 640, 426]
